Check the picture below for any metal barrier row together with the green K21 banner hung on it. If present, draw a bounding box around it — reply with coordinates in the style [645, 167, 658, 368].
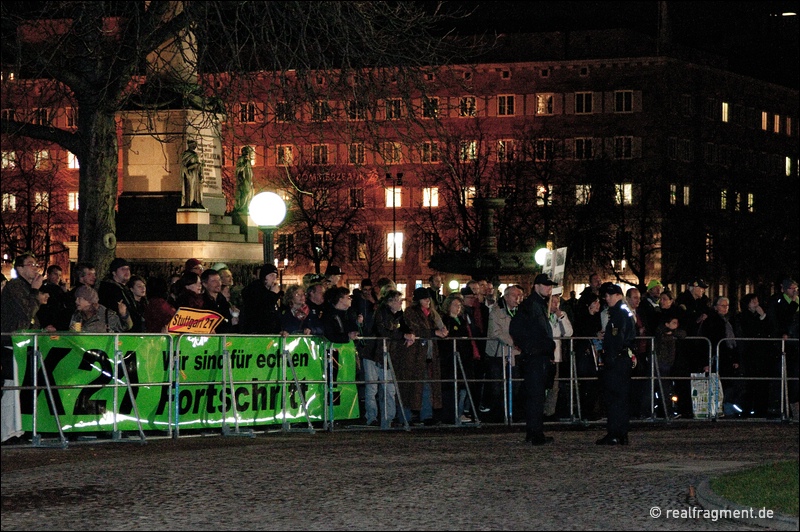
[2, 332, 798, 447]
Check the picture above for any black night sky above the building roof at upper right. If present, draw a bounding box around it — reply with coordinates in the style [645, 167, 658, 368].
[440, 0, 800, 89]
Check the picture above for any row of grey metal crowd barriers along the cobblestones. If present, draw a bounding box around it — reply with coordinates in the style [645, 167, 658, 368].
[3, 332, 798, 448]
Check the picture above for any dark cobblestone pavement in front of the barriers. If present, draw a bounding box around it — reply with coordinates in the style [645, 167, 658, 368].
[1, 421, 800, 530]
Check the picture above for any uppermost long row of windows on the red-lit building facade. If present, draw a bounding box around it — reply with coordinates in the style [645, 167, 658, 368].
[231, 90, 641, 124]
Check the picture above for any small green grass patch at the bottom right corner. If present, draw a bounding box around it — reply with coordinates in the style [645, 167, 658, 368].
[711, 460, 800, 516]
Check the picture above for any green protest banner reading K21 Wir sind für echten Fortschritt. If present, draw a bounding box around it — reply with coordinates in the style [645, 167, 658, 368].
[14, 333, 359, 432]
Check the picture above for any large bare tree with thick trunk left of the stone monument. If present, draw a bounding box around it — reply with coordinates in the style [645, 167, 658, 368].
[0, 1, 478, 271]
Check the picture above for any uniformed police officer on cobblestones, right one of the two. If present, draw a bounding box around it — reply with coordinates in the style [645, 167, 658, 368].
[596, 283, 636, 445]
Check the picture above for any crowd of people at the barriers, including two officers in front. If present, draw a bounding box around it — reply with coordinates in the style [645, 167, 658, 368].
[2, 254, 798, 445]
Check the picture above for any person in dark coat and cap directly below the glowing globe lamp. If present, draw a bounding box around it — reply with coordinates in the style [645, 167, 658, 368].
[239, 264, 281, 334]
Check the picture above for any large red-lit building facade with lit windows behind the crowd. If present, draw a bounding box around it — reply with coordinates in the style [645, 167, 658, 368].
[3, 31, 800, 302]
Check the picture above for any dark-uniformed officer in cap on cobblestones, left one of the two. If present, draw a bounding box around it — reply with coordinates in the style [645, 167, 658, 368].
[509, 273, 556, 445]
